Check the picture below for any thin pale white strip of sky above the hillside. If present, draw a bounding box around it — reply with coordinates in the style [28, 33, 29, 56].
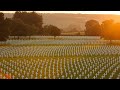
[0, 11, 120, 15]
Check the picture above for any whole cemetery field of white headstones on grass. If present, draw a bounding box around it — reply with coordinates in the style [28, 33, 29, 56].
[0, 36, 120, 79]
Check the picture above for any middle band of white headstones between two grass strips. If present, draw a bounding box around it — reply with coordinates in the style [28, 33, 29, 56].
[0, 45, 120, 57]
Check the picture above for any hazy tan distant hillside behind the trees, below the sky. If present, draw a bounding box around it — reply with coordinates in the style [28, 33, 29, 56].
[5, 13, 120, 31]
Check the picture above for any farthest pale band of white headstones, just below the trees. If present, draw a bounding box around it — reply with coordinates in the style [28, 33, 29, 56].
[4, 39, 110, 45]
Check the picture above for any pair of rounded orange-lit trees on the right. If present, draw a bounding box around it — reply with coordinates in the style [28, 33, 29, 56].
[85, 19, 120, 40]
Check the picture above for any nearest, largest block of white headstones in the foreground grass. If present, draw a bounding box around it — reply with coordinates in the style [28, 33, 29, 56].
[0, 57, 120, 78]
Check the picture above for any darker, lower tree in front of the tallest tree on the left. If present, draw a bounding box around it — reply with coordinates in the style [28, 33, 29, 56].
[10, 19, 38, 39]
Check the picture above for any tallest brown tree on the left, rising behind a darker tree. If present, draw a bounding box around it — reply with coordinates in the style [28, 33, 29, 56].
[13, 11, 43, 35]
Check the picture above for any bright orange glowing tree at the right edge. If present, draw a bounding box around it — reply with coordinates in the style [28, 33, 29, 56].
[101, 20, 120, 43]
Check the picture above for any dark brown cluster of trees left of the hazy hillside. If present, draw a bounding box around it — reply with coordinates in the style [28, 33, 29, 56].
[0, 11, 61, 41]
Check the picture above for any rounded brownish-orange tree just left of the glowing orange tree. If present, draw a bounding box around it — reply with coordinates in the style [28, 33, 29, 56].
[85, 20, 101, 36]
